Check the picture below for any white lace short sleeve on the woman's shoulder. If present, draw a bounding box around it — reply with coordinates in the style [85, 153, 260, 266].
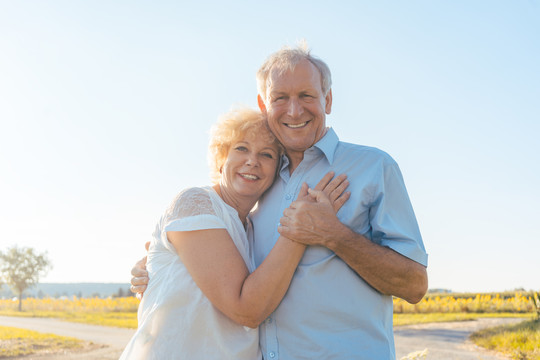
[164, 188, 226, 231]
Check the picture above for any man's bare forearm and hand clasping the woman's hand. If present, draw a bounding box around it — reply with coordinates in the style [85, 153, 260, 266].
[278, 192, 428, 304]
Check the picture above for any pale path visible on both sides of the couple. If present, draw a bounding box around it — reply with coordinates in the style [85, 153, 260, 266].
[0, 316, 522, 360]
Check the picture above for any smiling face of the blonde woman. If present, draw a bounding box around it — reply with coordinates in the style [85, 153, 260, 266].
[221, 134, 279, 200]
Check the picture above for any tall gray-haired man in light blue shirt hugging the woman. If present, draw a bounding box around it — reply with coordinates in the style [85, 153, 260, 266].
[132, 47, 427, 360]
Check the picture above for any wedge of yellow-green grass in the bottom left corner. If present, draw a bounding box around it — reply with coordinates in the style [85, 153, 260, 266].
[0, 326, 85, 359]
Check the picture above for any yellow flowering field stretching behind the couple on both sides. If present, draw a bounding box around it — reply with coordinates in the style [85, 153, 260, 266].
[0, 292, 535, 328]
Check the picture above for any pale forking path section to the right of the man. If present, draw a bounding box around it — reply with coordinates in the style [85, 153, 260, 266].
[394, 319, 523, 360]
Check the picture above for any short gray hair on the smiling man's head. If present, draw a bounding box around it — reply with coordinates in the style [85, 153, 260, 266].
[257, 41, 332, 101]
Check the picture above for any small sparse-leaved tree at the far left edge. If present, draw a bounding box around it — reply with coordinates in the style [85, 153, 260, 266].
[0, 246, 52, 311]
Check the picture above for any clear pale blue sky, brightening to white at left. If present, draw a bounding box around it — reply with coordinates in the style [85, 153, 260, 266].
[0, 0, 540, 291]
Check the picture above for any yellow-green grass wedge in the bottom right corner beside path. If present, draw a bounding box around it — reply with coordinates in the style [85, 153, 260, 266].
[471, 319, 540, 360]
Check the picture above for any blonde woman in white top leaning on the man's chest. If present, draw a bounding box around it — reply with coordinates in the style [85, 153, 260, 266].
[121, 109, 346, 360]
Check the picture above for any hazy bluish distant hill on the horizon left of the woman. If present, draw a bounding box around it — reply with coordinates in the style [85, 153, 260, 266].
[0, 283, 131, 298]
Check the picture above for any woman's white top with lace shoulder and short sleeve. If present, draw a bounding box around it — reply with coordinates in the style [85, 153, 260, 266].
[120, 187, 261, 360]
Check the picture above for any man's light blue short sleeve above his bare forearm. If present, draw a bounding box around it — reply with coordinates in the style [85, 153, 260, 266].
[369, 158, 428, 266]
